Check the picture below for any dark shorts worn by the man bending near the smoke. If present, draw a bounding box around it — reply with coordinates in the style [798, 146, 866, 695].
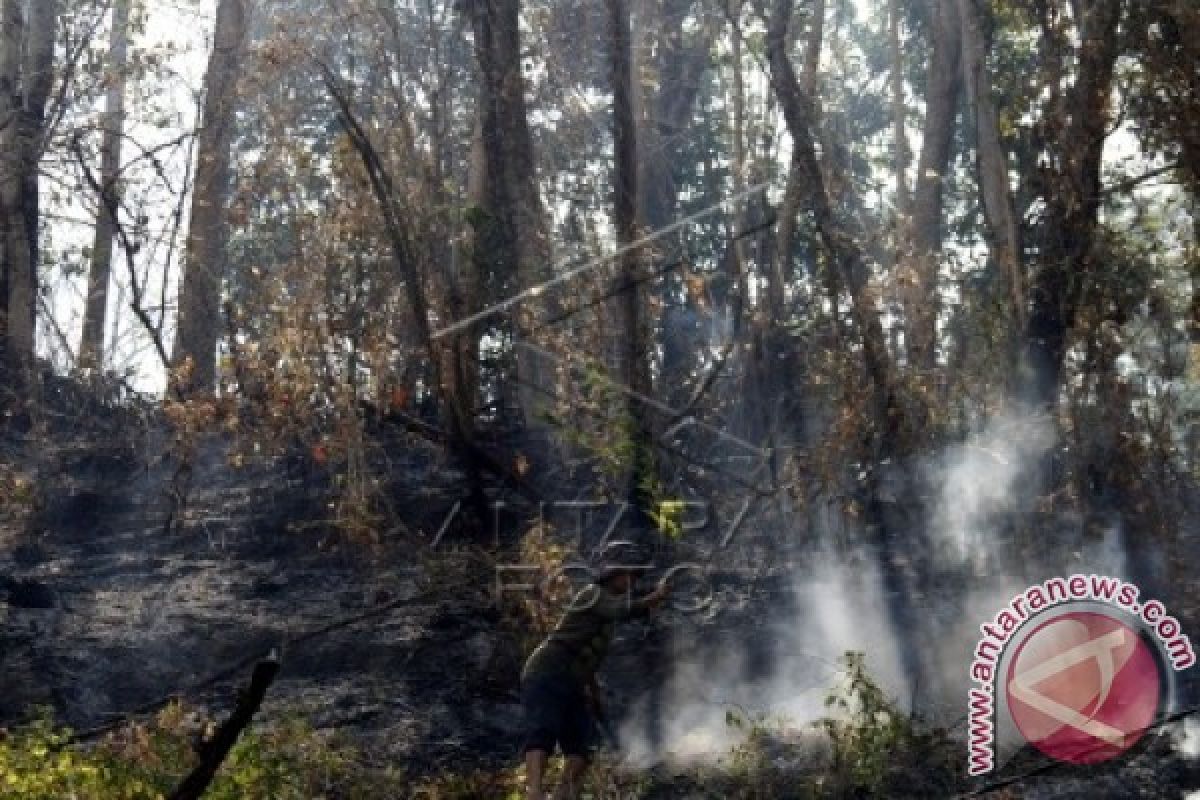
[521, 675, 593, 756]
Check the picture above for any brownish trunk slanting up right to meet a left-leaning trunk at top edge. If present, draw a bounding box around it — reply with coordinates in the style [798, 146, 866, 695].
[906, 0, 962, 369]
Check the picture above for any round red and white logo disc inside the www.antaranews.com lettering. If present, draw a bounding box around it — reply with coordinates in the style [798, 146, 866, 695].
[1004, 612, 1164, 764]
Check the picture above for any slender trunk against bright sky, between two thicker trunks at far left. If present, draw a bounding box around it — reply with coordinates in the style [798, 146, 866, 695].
[79, 0, 130, 369]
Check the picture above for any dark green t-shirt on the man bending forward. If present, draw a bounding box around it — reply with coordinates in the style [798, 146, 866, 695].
[521, 584, 649, 686]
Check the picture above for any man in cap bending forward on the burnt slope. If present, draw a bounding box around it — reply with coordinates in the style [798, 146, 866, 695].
[521, 561, 670, 800]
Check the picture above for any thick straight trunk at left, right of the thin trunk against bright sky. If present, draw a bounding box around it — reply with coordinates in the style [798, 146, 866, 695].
[172, 0, 246, 392]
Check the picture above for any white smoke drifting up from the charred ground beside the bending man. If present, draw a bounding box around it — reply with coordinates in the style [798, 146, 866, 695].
[622, 415, 1124, 764]
